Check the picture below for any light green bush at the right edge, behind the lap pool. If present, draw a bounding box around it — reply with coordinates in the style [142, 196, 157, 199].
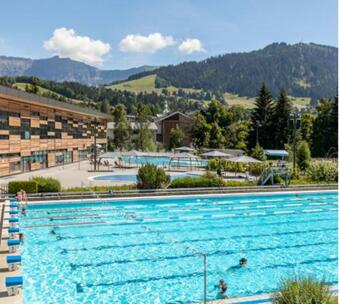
[306, 162, 338, 182]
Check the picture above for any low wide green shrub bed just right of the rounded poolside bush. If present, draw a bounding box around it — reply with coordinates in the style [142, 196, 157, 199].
[170, 173, 225, 188]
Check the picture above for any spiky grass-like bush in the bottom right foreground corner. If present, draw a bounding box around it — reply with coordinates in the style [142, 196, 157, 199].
[273, 278, 333, 304]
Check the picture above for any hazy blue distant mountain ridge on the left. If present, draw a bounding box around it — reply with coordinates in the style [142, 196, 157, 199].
[0, 56, 155, 85]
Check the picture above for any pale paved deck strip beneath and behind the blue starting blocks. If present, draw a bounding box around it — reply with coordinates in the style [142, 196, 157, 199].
[0, 203, 23, 304]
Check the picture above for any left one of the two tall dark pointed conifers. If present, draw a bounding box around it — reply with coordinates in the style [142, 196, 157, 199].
[248, 83, 275, 148]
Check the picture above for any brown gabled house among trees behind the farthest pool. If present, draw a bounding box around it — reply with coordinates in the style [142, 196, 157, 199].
[155, 112, 194, 148]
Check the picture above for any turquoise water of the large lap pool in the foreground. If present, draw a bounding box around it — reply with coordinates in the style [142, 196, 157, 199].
[21, 192, 338, 304]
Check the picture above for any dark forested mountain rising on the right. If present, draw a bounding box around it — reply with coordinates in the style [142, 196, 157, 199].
[129, 43, 338, 100]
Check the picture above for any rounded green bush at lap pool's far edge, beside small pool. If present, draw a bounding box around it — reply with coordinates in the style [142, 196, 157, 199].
[137, 164, 170, 189]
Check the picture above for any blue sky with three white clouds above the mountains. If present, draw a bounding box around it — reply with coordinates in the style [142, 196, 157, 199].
[0, 0, 338, 69]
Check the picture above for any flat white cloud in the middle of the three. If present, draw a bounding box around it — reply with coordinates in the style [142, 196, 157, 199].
[119, 33, 175, 53]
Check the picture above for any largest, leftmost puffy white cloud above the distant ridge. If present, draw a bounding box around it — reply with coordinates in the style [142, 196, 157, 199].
[44, 27, 111, 64]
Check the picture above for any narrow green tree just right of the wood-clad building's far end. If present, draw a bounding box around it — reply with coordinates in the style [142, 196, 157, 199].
[112, 103, 131, 151]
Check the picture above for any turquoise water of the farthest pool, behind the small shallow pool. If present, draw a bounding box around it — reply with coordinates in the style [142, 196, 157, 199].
[122, 156, 208, 167]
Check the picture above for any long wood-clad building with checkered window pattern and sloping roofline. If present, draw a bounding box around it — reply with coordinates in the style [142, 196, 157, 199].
[0, 86, 111, 176]
